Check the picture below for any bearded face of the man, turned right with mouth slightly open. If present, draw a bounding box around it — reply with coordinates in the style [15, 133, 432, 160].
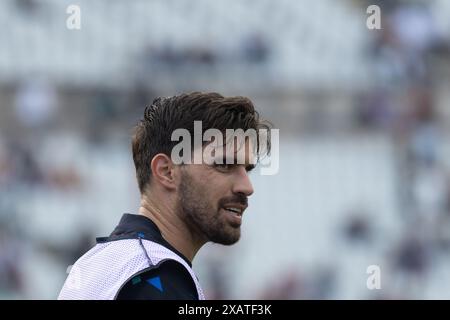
[178, 141, 253, 245]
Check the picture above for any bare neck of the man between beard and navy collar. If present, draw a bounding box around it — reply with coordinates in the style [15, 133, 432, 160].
[139, 196, 206, 263]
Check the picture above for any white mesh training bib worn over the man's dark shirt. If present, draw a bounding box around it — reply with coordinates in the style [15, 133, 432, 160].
[58, 239, 205, 300]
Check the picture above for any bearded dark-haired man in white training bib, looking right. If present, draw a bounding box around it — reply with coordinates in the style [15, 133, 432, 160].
[59, 92, 270, 299]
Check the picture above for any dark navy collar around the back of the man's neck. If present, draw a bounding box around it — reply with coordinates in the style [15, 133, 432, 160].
[97, 213, 192, 268]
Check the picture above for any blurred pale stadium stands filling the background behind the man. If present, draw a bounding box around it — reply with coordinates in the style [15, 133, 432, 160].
[0, 0, 450, 299]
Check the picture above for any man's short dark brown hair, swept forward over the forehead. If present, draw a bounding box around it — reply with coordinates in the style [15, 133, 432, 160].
[132, 92, 271, 193]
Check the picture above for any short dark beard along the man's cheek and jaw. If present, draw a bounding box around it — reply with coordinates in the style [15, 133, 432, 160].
[178, 172, 241, 245]
